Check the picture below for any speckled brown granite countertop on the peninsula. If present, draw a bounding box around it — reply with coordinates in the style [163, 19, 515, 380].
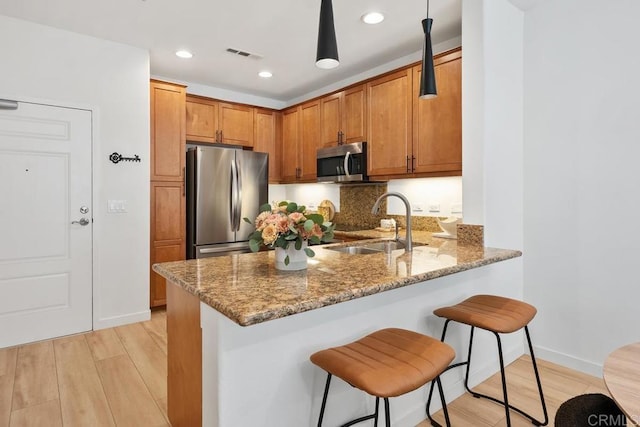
[153, 231, 522, 326]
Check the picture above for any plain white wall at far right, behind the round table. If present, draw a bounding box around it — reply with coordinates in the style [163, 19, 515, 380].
[524, 0, 640, 375]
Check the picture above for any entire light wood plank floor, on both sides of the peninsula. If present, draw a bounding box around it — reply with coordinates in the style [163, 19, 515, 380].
[0, 311, 607, 427]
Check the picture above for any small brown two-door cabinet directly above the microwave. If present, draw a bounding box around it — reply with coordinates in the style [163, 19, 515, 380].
[320, 85, 367, 147]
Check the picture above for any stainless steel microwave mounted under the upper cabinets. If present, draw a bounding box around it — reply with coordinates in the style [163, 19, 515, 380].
[316, 142, 368, 182]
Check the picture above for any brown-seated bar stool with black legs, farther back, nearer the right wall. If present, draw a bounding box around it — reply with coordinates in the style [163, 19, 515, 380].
[427, 295, 549, 426]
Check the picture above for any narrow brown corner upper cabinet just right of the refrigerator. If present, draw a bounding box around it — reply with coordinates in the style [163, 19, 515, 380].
[253, 108, 282, 183]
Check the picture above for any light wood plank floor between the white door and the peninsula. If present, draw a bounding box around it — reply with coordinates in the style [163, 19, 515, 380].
[0, 312, 169, 427]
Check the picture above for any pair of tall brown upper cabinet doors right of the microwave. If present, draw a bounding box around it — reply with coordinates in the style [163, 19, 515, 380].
[367, 49, 462, 179]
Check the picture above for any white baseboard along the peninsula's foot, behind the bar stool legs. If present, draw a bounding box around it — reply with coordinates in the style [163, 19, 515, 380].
[394, 346, 524, 427]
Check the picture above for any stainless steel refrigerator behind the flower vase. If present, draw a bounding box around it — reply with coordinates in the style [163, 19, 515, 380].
[186, 146, 269, 259]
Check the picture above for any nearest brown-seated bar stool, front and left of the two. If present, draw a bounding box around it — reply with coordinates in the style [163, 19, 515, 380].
[310, 328, 455, 427]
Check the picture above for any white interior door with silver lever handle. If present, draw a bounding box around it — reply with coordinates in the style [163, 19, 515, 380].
[0, 102, 93, 347]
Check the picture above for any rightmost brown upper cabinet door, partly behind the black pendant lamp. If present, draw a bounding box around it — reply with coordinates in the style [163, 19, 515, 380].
[413, 50, 462, 173]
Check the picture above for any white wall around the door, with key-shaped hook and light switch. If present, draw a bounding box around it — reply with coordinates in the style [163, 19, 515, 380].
[0, 16, 149, 328]
